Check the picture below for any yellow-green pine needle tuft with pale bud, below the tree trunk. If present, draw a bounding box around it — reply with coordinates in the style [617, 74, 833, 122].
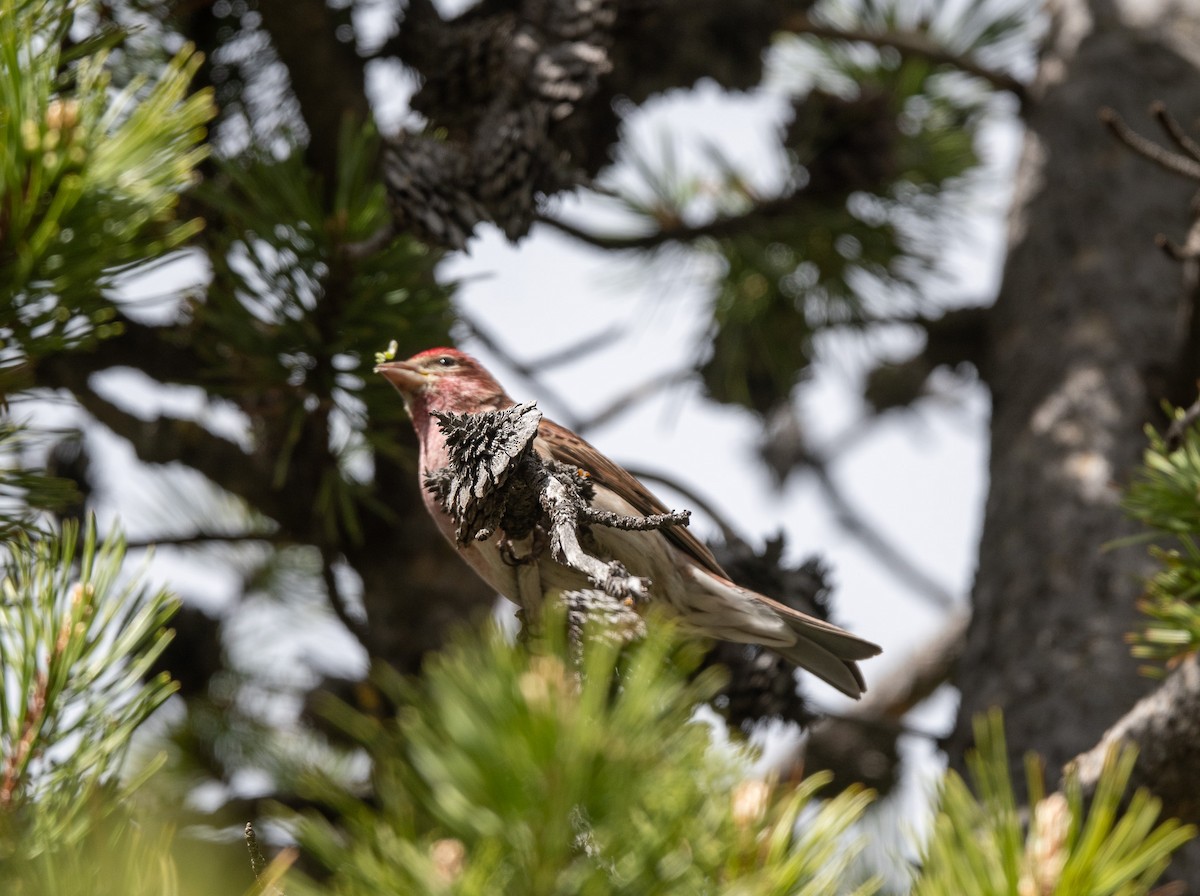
[913, 711, 1195, 896]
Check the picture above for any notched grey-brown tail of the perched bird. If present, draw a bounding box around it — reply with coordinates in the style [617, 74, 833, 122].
[690, 566, 882, 699]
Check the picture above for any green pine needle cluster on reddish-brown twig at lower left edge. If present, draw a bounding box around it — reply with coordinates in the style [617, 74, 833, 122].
[0, 523, 176, 892]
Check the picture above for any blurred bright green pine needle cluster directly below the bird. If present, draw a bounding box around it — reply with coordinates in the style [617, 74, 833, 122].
[286, 620, 874, 896]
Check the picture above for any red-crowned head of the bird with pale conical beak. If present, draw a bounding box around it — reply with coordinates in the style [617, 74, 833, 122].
[374, 348, 512, 422]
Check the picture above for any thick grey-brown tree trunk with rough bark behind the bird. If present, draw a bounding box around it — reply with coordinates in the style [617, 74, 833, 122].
[948, 0, 1200, 810]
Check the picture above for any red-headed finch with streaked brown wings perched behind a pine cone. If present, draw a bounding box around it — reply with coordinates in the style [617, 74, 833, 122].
[374, 348, 881, 699]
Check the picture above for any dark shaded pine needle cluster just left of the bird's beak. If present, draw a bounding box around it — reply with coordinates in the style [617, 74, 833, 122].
[194, 122, 454, 541]
